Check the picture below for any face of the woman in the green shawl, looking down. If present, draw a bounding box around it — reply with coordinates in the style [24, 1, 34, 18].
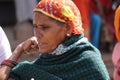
[33, 12, 69, 53]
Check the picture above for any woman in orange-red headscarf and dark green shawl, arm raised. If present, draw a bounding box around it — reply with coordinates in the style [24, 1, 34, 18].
[0, 0, 110, 80]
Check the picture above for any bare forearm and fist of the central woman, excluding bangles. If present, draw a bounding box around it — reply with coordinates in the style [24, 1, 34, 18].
[0, 37, 37, 80]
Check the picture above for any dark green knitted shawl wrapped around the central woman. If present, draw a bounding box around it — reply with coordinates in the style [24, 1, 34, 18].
[10, 35, 110, 80]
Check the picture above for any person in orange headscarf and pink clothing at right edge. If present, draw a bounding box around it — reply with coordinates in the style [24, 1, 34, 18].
[112, 0, 120, 80]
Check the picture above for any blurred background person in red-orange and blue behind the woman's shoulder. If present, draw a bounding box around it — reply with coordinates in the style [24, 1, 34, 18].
[73, 0, 102, 48]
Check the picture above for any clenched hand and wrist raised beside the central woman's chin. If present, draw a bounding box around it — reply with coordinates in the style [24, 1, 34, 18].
[12, 37, 39, 61]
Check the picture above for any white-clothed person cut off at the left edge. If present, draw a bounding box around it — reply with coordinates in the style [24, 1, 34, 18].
[0, 26, 12, 64]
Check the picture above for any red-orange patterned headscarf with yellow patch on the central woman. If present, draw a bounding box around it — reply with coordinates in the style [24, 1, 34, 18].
[33, 0, 84, 34]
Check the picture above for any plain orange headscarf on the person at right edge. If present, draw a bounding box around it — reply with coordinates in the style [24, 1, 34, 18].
[114, 6, 120, 42]
